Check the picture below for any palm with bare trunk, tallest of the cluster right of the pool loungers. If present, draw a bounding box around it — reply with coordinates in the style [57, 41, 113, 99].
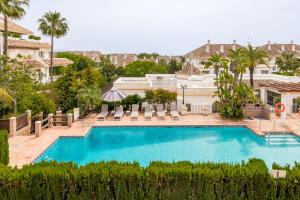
[243, 44, 268, 87]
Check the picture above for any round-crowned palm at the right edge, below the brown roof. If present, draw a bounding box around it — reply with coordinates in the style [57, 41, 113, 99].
[275, 53, 300, 73]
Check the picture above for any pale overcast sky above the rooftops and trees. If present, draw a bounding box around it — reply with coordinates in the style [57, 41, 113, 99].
[20, 0, 300, 55]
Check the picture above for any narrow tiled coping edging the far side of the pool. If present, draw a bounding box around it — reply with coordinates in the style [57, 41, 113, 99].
[31, 125, 300, 164]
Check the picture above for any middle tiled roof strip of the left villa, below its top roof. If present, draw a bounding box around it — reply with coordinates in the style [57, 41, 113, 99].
[8, 39, 51, 49]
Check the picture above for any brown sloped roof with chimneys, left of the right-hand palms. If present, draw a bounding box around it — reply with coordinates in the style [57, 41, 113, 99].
[184, 43, 245, 59]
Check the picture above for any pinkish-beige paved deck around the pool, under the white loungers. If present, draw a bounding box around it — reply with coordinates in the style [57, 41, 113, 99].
[9, 114, 300, 167]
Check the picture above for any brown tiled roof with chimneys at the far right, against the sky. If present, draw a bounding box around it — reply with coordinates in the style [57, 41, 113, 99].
[258, 43, 300, 56]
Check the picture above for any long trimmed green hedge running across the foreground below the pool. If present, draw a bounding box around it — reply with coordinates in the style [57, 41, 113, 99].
[0, 159, 300, 200]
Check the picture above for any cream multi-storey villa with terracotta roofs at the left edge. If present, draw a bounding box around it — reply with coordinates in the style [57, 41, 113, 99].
[0, 17, 72, 83]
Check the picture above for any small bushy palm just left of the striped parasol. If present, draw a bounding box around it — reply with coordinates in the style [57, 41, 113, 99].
[76, 86, 101, 113]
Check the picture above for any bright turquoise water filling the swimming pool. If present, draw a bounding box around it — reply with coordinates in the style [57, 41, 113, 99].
[36, 127, 300, 167]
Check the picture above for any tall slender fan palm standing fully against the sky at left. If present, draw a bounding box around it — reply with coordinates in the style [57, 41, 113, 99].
[39, 11, 69, 82]
